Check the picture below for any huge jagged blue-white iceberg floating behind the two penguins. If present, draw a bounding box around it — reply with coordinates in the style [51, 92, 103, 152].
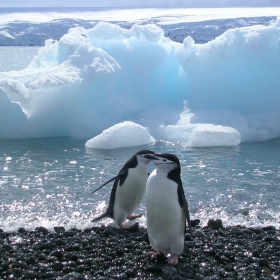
[0, 14, 280, 148]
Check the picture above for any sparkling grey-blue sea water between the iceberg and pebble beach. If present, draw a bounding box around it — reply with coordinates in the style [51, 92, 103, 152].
[0, 138, 280, 231]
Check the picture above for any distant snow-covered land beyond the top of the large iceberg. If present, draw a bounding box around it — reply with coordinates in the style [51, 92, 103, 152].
[0, 7, 280, 46]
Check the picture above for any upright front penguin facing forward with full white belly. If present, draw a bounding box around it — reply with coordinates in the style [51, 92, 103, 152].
[146, 154, 191, 265]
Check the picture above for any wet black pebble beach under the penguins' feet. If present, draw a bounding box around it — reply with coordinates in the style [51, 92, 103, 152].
[0, 220, 280, 280]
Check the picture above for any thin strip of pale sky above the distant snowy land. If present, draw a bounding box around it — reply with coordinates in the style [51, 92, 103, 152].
[0, 0, 280, 8]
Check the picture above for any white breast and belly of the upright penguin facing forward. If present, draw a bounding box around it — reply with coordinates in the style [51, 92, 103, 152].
[146, 169, 185, 255]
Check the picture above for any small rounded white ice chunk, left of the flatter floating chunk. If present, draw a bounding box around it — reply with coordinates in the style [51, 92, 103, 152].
[85, 121, 155, 149]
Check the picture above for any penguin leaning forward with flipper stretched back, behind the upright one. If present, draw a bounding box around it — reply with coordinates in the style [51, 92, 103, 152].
[90, 150, 156, 229]
